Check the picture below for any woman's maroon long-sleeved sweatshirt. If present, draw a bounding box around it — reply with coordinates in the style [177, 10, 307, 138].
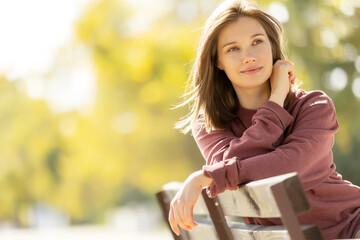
[193, 89, 360, 239]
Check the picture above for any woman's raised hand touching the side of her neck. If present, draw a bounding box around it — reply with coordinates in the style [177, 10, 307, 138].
[269, 60, 296, 107]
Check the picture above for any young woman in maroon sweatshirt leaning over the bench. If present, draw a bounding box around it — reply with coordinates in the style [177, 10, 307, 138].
[169, 0, 360, 239]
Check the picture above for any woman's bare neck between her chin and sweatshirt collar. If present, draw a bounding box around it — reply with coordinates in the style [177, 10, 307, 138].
[235, 81, 270, 110]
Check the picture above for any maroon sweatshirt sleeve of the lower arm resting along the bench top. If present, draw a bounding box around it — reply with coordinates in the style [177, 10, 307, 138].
[203, 95, 338, 197]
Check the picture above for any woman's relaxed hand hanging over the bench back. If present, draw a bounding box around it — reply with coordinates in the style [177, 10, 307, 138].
[169, 170, 212, 235]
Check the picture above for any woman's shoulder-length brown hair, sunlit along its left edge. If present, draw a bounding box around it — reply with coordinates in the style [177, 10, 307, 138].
[176, 0, 285, 133]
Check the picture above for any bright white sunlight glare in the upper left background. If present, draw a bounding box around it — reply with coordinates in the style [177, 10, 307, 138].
[0, 0, 94, 111]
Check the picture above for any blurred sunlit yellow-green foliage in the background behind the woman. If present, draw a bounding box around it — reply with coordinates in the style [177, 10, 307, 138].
[0, 0, 360, 226]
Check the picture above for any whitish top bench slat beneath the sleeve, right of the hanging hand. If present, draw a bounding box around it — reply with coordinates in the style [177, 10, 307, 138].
[217, 173, 310, 218]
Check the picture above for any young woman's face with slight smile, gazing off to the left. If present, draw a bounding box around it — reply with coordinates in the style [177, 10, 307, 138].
[217, 17, 273, 90]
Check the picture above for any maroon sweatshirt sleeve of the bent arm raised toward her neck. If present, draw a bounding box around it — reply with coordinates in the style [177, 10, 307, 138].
[193, 101, 293, 165]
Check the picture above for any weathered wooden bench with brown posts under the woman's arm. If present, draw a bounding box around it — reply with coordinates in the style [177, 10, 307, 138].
[156, 173, 323, 240]
